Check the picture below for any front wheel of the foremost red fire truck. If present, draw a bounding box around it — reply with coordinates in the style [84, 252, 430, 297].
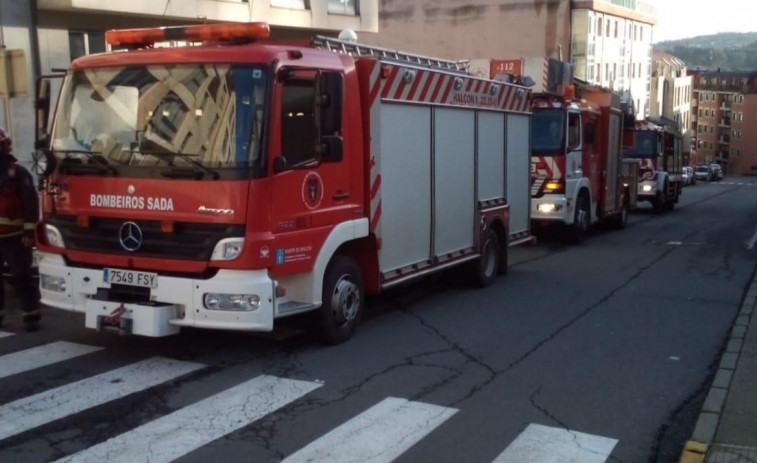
[321, 255, 365, 345]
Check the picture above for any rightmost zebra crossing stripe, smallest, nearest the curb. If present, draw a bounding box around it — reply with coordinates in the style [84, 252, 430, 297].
[494, 424, 618, 463]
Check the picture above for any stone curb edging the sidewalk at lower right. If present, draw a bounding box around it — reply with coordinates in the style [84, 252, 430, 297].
[678, 276, 757, 463]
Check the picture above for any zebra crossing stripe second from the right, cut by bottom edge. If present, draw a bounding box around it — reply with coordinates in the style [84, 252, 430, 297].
[282, 397, 457, 463]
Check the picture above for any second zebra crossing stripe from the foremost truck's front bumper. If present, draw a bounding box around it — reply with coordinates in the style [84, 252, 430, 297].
[0, 357, 204, 440]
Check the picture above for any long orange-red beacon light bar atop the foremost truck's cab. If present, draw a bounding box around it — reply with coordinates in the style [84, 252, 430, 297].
[105, 22, 271, 47]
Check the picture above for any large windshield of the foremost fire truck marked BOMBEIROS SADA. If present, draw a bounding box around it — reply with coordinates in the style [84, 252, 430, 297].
[52, 64, 267, 178]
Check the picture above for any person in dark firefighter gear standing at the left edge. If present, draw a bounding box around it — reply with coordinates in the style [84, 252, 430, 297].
[0, 128, 40, 331]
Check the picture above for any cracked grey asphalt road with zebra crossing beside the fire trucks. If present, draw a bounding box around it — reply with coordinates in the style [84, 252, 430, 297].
[0, 178, 757, 463]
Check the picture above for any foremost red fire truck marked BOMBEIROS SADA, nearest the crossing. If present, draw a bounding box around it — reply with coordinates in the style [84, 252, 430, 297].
[38, 23, 531, 343]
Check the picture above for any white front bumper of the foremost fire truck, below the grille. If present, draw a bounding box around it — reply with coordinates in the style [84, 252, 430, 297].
[39, 253, 275, 336]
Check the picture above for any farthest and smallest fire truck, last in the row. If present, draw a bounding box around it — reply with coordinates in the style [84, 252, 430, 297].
[623, 120, 683, 212]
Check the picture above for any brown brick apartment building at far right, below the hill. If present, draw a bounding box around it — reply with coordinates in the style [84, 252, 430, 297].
[689, 71, 757, 175]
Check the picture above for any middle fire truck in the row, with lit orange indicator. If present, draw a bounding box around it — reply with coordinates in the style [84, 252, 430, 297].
[531, 79, 635, 242]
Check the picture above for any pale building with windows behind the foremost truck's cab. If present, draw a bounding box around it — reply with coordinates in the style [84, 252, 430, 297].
[0, 0, 379, 162]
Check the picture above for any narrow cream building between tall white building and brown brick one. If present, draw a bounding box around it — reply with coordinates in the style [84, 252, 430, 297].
[649, 50, 692, 164]
